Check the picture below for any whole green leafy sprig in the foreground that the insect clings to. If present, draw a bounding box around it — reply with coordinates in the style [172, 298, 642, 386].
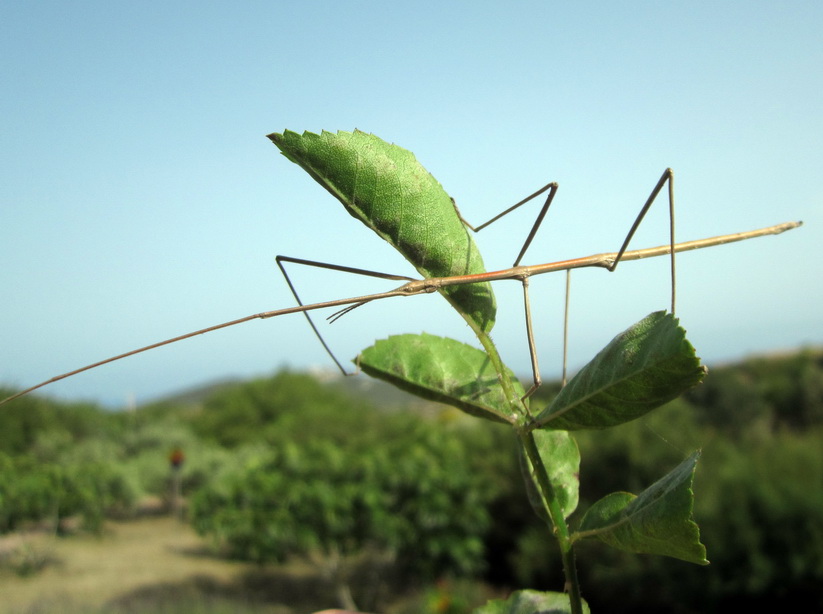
[270, 131, 752, 613]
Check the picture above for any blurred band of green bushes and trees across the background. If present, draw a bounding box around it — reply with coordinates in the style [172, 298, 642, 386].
[0, 350, 823, 613]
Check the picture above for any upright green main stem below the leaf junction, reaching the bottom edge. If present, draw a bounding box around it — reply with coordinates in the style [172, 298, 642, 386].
[518, 430, 583, 614]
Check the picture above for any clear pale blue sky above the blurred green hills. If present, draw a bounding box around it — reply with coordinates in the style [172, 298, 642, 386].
[0, 1, 823, 407]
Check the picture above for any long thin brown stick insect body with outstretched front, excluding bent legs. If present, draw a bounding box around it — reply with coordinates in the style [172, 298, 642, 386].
[0, 222, 802, 405]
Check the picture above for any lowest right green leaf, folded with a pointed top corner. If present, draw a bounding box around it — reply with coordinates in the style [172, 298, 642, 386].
[573, 452, 709, 565]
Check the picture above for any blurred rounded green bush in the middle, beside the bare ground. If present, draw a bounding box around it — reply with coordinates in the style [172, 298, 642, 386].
[190, 420, 490, 608]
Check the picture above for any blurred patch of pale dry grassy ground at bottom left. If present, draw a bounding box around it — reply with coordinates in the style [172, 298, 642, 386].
[0, 518, 335, 614]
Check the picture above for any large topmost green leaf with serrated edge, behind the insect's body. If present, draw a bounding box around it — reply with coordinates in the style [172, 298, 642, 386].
[269, 130, 496, 332]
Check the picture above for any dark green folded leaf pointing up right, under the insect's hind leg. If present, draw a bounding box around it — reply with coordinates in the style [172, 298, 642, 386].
[536, 311, 706, 430]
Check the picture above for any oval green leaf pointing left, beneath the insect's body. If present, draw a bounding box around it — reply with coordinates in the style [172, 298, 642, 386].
[356, 333, 524, 423]
